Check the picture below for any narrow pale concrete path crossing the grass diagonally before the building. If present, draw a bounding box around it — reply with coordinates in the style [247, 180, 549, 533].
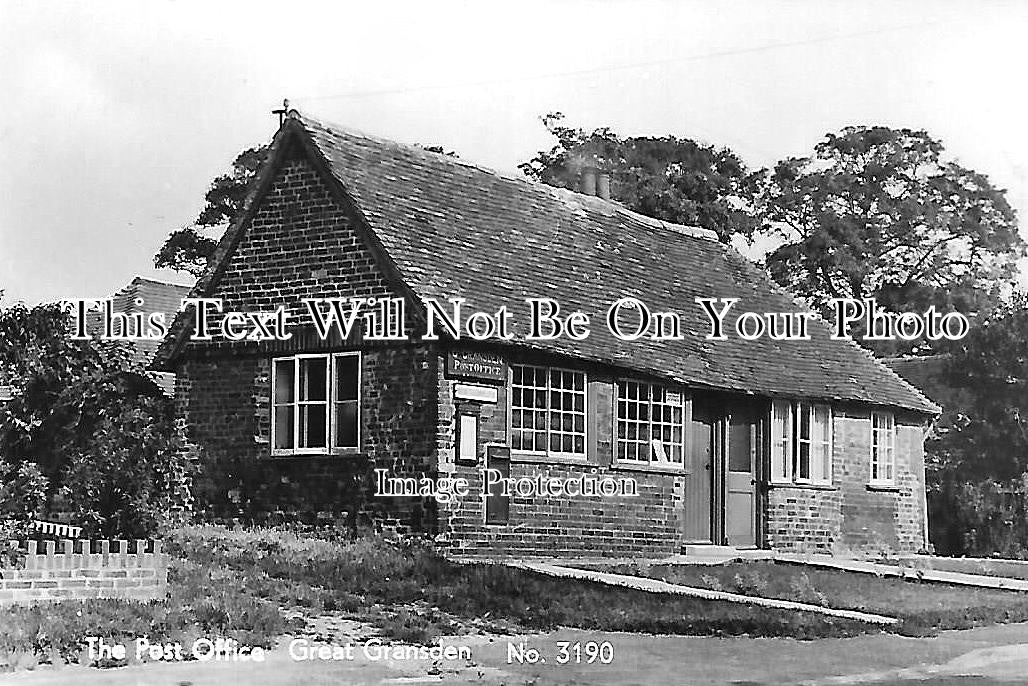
[504, 561, 900, 625]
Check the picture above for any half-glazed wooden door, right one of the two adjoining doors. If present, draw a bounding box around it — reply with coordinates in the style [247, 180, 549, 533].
[725, 408, 759, 547]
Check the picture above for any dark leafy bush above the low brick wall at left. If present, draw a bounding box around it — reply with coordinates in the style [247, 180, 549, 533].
[0, 304, 190, 538]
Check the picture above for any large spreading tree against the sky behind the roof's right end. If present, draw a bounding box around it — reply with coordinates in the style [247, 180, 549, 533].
[761, 127, 1025, 333]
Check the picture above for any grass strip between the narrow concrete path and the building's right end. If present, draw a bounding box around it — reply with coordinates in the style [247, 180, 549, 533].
[609, 561, 1028, 636]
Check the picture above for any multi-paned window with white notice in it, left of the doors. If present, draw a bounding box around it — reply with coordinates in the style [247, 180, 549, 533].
[616, 381, 686, 467]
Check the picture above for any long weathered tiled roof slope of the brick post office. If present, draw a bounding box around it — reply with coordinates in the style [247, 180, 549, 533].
[154, 115, 939, 413]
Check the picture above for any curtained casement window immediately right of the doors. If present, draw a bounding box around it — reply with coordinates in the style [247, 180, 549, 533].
[770, 400, 832, 483]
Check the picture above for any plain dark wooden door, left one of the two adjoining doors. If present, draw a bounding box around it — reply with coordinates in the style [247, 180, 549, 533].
[685, 404, 714, 543]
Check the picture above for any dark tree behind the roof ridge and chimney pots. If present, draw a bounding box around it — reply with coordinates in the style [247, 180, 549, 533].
[519, 112, 763, 242]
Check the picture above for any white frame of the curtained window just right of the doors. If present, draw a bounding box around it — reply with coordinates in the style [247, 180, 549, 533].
[768, 400, 835, 485]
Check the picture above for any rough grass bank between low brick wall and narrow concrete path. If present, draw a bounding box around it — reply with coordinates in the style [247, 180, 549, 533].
[169, 527, 875, 641]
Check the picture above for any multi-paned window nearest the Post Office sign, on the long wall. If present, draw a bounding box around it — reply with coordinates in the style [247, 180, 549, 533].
[510, 364, 586, 458]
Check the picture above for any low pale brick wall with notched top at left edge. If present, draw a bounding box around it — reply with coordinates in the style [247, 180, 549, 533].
[0, 540, 168, 606]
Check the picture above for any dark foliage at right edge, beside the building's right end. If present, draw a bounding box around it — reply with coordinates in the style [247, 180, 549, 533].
[925, 294, 1028, 556]
